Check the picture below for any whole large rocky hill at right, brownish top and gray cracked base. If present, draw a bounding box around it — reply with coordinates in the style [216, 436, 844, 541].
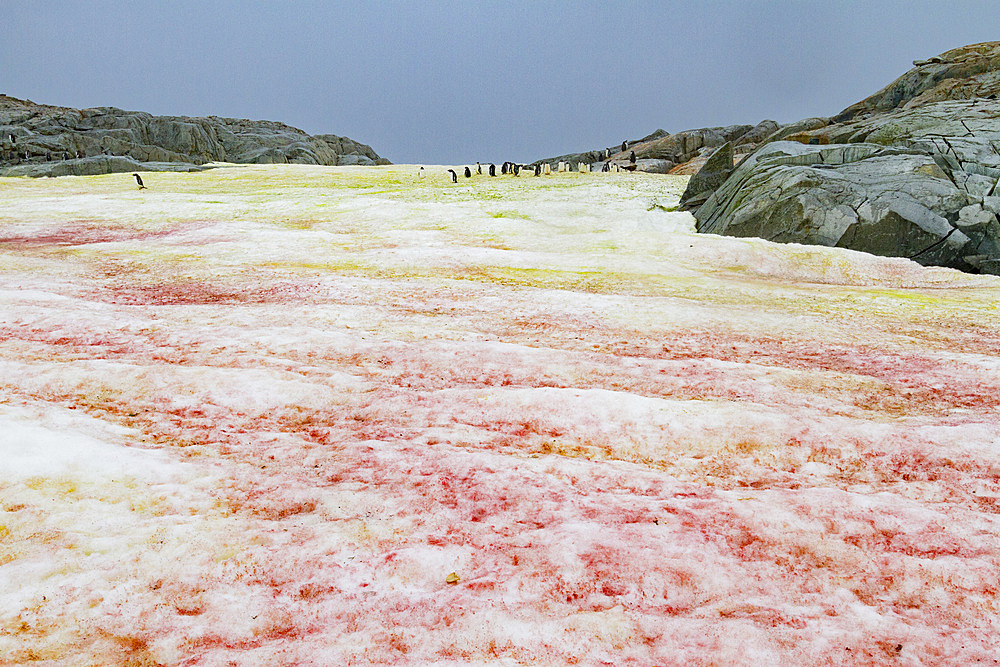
[682, 42, 1000, 274]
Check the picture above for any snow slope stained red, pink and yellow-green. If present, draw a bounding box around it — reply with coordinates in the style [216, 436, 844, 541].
[0, 166, 1000, 665]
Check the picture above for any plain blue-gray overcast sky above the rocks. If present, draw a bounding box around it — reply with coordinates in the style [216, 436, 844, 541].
[0, 0, 1000, 164]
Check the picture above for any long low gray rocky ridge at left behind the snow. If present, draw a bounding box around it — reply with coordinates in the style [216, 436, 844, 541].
[0, 95, 388, 176]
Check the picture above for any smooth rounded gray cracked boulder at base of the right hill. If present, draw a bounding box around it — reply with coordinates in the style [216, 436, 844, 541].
[695, 142, 1000, 270]
